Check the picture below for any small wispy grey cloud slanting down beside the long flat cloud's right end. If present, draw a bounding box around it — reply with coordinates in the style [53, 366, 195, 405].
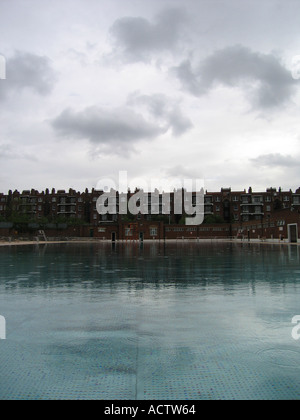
[128, 94, 193, 137]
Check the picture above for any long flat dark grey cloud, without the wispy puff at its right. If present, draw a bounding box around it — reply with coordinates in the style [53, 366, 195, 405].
[52, 106, 166, 152]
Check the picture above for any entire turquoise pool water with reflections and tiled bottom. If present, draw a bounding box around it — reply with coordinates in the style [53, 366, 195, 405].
[0, 243, 300, 400]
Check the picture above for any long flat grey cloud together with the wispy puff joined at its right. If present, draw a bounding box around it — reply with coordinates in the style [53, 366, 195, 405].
[51, 92, 193, 154]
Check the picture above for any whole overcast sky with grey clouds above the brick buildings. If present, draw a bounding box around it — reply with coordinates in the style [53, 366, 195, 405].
[0, 0, 300, 193]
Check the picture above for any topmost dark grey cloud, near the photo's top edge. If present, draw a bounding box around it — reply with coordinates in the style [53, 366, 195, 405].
[110, 9, 187, 62]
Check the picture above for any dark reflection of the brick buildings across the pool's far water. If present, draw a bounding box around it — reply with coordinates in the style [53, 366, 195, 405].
[0, 243, 300, 293]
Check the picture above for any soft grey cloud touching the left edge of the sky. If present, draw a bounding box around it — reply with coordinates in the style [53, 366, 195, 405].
[0, 51, 56, 98]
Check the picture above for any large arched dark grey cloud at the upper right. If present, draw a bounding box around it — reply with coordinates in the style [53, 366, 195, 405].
[172, 45, 297, 109]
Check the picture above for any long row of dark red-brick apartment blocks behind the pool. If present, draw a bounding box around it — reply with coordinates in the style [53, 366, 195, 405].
[0, 187, 300, 240]
